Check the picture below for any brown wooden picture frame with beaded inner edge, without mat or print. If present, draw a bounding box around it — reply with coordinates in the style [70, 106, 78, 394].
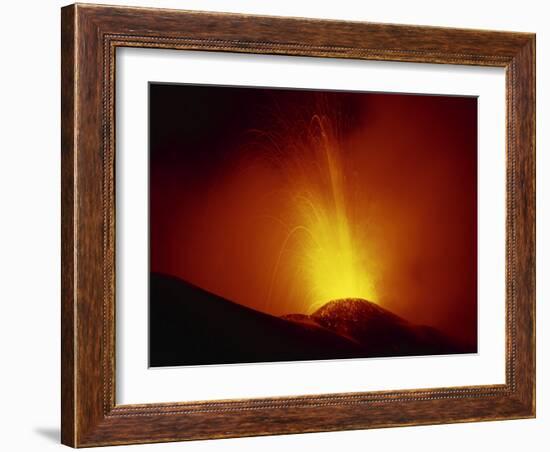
[61, 4, 535, 447]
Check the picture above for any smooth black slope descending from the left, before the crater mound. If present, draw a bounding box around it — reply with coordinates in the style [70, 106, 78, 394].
[149, 274, 362, 367]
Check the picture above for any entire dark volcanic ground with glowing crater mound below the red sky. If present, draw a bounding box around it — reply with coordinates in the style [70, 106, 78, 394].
[149, 273, 475, 367]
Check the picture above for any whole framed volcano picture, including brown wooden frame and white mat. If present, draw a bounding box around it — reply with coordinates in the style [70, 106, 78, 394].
[61, 4, 535, 447]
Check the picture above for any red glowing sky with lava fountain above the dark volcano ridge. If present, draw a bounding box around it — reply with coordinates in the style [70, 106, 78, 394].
[150, 84, 477, 343]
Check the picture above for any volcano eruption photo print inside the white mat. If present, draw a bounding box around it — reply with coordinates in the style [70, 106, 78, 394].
[149, 82, 478, 367]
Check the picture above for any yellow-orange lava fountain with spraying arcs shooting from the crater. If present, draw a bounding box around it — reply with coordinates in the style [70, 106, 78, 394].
[262, 105, 377, 313]
